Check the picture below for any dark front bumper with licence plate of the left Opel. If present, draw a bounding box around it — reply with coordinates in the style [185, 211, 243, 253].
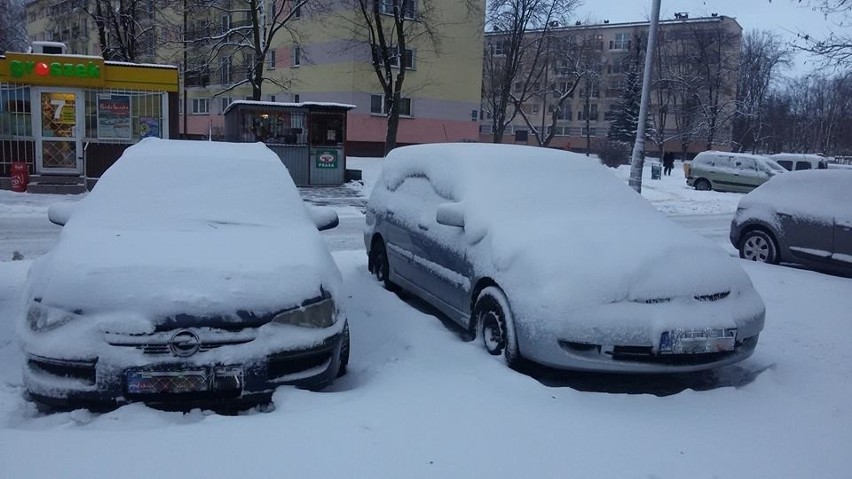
[23, 328, 343, 409]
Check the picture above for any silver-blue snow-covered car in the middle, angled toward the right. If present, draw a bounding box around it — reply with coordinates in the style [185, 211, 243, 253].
[364, 144, 765, 373]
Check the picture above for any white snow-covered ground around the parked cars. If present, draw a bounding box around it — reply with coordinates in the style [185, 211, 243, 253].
[0, 159, 852, 478]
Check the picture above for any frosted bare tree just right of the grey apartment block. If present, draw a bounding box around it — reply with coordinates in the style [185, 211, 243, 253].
[733, 31, 791, 152]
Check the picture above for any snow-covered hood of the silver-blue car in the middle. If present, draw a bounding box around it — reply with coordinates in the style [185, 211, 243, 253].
[472, 208, 753, 316]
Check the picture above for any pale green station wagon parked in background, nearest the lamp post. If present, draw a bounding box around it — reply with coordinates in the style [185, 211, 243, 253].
[686, 151, 787, 193]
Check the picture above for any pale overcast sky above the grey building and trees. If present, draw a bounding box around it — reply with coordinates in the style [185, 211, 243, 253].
[577, 0, 832, 75]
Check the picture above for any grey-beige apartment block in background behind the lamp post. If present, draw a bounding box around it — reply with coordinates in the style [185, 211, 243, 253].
[480, 13, 742, 156]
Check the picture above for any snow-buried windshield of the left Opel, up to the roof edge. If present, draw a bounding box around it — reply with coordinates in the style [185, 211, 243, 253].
[72, 141, 305, 230]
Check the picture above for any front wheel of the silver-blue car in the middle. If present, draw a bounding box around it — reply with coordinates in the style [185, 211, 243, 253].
[473, 286, 521, 369]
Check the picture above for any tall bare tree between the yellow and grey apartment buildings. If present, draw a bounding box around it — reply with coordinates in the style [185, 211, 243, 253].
[482, 0, 578, 143]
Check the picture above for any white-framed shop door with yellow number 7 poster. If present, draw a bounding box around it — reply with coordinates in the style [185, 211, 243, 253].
[32, 88, 84, 174]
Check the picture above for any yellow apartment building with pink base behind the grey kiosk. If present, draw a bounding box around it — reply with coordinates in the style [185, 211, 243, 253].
[27, 0, 484, 155]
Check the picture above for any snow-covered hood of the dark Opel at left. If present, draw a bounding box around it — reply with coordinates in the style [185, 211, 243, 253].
[26, 223, 341, 322]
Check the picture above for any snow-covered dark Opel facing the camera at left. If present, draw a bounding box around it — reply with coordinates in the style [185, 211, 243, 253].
[18, 138, 349, 407]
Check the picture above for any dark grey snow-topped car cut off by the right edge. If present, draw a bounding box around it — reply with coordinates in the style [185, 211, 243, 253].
[730, 169, 852, 274]
